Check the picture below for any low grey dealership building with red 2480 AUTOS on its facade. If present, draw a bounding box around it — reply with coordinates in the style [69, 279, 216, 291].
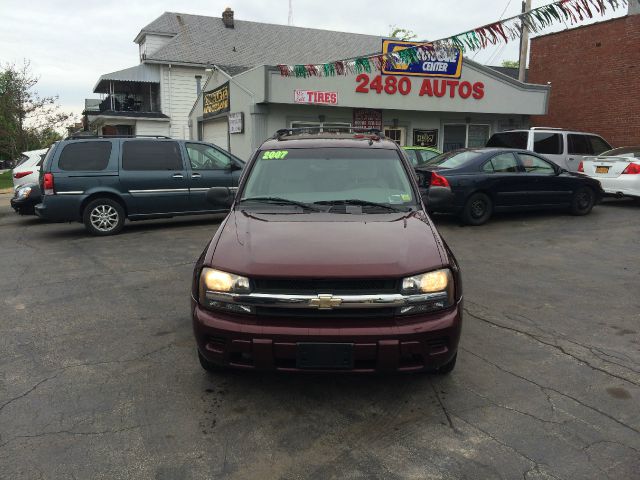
[189, 59, 549, 158]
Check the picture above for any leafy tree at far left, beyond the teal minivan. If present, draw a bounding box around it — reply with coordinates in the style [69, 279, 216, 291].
[0, 60, 72, 159]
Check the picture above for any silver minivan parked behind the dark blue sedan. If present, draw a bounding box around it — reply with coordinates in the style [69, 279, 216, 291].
[487, 127, 611, 172]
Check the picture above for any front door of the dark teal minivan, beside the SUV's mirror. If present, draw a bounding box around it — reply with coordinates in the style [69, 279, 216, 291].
[185, 142, 237, 211]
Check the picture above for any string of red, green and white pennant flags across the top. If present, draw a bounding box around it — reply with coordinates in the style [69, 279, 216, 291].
[278, 0, 640, 78]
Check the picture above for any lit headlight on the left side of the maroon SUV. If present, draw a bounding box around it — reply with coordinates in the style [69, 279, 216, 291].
[199, 267, 254, 313]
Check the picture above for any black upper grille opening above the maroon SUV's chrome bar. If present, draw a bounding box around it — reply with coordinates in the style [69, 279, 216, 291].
[254, 278, 399, 295]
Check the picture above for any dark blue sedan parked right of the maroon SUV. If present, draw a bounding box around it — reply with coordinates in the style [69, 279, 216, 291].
[416, 148, 604, 225]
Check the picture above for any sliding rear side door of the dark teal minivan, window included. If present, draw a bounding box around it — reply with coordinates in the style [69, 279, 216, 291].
[120, 139, 189, 216]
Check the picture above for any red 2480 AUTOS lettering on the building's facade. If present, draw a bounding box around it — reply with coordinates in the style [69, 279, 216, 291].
[356, 73, 484, 100]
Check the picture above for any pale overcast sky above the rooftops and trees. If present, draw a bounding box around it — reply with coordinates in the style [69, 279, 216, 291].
[0, 0, 626, 120]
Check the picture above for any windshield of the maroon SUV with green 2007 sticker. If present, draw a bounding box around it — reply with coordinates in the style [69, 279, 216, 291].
[242, 148, 416, 207]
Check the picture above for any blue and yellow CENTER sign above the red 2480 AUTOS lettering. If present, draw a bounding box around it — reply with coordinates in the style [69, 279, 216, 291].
[382, 40, 462, 78]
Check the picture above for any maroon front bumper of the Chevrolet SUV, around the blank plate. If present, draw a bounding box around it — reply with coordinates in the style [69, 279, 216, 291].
[191, 298, 462, 373]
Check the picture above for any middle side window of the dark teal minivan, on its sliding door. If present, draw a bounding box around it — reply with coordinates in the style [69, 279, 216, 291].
[122, 140, 183, 170]
